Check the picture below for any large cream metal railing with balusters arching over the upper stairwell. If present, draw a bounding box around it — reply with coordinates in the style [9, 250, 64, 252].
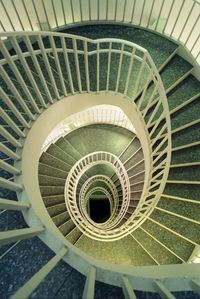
[0, 32, 171, 241]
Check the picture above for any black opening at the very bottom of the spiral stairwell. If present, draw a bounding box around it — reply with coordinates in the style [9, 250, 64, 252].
[89, 198, 110, 223]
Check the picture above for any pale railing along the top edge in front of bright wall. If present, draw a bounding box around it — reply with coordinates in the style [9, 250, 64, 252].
[0, 0, 200, 63]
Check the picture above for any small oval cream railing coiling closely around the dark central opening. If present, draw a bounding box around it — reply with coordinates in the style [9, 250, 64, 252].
[65, 152, 130, 241]
